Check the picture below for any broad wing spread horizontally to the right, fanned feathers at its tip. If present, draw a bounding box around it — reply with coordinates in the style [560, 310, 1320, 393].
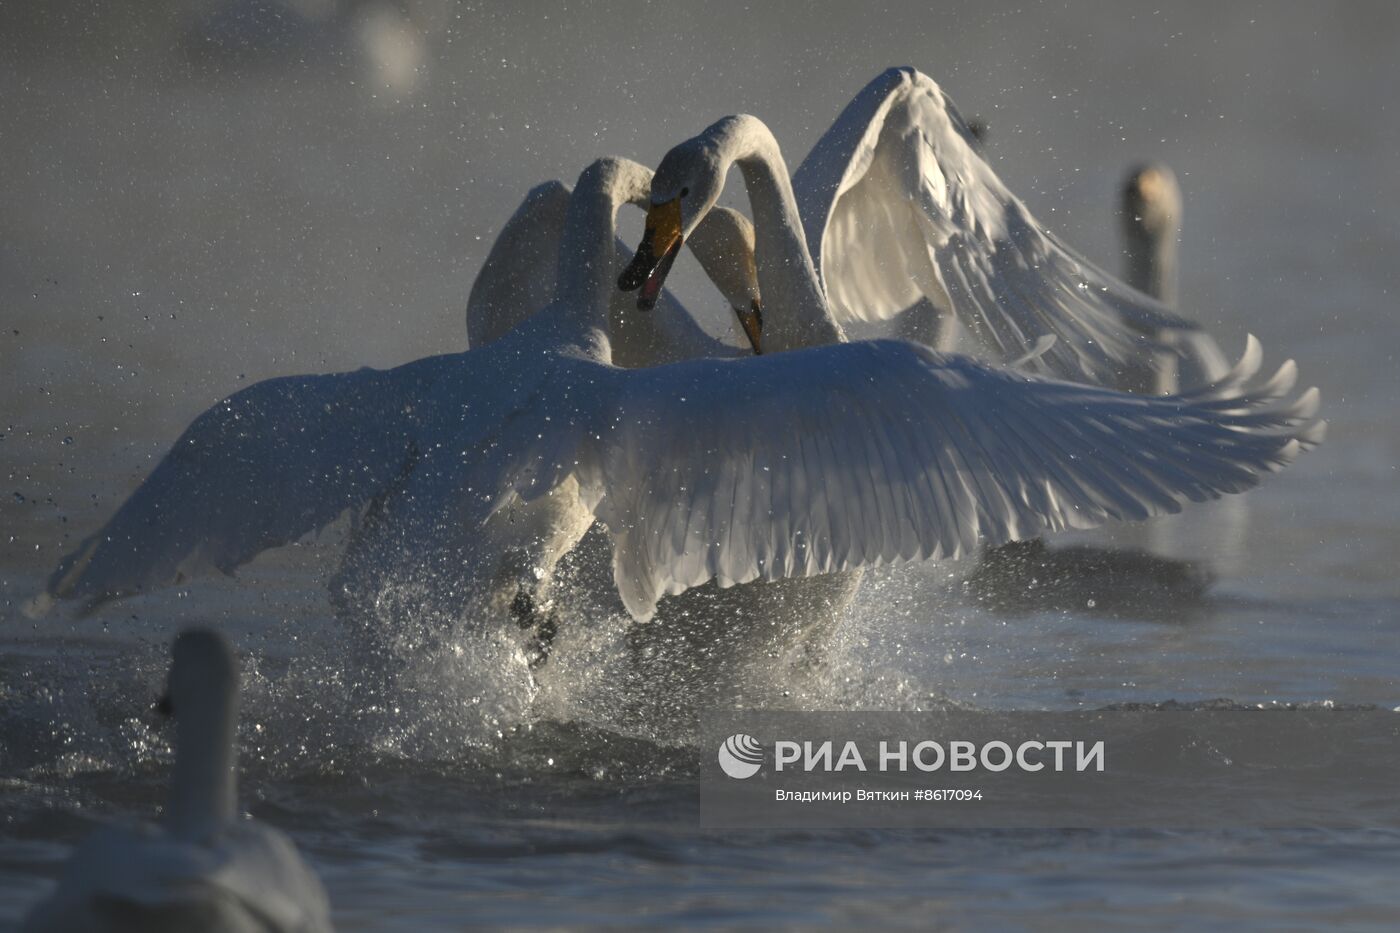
[568, 339, 1323, 618]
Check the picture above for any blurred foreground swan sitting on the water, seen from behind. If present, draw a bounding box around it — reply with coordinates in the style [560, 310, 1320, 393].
[22, 629, 332, 933]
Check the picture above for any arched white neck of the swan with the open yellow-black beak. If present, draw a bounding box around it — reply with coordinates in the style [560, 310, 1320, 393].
[700, 115, 846, 350]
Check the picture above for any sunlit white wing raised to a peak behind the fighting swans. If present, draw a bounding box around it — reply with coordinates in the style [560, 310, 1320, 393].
[794, 67, 1197, 384]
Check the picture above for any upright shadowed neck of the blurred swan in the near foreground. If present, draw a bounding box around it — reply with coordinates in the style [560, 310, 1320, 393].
[167, 689, 238, 842]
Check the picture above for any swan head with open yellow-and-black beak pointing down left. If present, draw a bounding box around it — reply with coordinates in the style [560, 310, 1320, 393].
[617, 137, 725, 311]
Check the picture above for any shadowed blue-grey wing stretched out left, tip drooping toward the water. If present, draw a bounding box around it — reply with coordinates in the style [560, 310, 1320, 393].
[48, 357, 431, 602]
